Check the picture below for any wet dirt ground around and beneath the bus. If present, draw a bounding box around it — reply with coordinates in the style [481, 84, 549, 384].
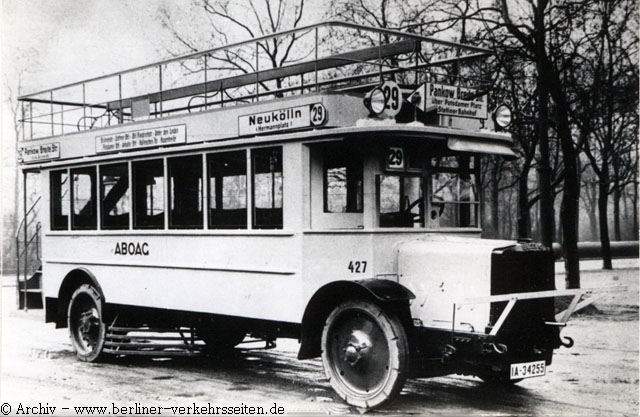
[0, 259, 640, 416]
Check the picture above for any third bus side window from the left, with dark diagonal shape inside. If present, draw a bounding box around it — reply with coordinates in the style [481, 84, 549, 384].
[100, 163, 129, 229]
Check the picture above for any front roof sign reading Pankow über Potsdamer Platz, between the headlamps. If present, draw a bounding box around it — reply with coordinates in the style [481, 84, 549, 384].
[425, 83, 487, 119]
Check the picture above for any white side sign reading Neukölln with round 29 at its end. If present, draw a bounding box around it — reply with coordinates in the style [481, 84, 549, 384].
[238, 103, 327, 136]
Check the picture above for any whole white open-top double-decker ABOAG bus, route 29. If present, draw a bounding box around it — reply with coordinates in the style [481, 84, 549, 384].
[15, 22, 580, 408]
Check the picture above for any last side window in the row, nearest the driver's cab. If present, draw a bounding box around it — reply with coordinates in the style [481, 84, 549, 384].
[251, 147, 282, 229]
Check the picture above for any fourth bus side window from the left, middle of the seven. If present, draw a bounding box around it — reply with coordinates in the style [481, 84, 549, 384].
[131, 159, 164, 229]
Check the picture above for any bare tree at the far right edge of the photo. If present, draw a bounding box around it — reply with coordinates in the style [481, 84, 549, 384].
[568, 0, 638, 269]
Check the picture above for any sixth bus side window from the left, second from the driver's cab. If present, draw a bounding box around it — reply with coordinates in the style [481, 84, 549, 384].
[207, 151, 247, 229]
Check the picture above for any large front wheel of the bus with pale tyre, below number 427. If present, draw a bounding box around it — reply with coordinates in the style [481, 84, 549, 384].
[322, 301, 409, 408]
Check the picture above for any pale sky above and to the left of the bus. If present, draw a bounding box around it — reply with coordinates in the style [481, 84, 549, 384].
[0, 0, 325, 260]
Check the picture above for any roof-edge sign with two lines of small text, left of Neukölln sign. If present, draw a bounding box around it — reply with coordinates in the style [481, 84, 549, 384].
[96, 125, 187, 153]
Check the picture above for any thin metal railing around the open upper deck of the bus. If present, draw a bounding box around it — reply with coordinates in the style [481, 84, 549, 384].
[19, 22, 490, 140]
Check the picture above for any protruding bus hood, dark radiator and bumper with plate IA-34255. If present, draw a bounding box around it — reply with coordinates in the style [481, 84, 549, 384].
[398, 236, 571, 384]
